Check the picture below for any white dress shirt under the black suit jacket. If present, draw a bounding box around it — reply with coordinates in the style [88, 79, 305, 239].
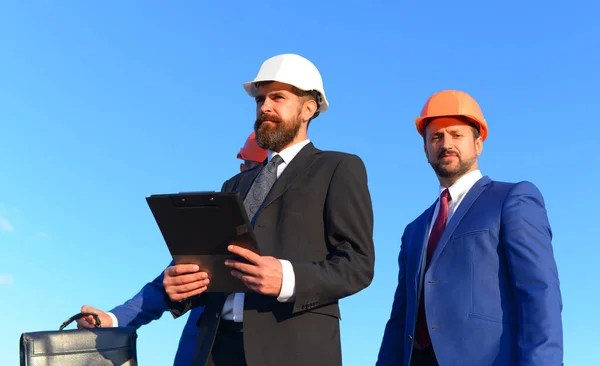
[221, 139, 310, 322]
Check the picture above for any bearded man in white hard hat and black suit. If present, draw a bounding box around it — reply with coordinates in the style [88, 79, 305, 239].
[159, 54, 375, 366]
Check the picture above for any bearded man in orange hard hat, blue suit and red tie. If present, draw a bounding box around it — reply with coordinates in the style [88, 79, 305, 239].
[377, 90, 563, 366]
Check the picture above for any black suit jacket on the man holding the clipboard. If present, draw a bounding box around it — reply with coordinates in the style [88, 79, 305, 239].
[166, 143, 375, 366]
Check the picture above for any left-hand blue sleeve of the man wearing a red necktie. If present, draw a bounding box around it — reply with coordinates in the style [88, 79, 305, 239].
[376, 235, 406, 366]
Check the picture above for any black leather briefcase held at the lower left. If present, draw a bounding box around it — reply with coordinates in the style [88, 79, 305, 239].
[19, 313, 137, 366]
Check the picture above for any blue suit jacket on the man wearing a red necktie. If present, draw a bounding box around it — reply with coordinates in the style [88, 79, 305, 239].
[377, 177, 563, 366]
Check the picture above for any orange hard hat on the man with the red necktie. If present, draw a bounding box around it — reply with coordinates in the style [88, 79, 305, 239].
[415, 90, 488, 140]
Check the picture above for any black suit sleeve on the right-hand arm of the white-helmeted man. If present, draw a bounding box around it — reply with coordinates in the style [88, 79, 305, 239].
[292, 155, 375, 312]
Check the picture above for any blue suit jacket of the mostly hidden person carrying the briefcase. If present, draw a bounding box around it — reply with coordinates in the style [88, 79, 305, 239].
[111, 264, 204, 366]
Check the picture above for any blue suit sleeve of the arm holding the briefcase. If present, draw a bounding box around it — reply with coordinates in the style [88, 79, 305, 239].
[110, 262, 172, 329]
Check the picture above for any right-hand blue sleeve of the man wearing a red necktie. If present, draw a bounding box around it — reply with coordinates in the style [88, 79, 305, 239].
[502, 182, 563, 366]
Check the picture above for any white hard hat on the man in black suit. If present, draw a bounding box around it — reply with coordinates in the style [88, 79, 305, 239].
[244, 53, 329, 113]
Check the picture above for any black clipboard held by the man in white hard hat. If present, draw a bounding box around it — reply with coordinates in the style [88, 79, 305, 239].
[146, 192, 260, 292]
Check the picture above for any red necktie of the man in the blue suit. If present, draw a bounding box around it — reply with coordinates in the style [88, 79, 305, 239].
[416, 188, 450, 348]
